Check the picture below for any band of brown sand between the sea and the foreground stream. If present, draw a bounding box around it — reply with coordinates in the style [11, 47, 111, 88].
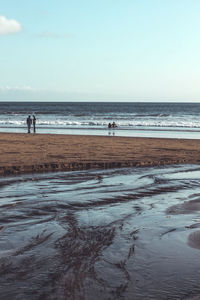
[0, 133, 200, 175]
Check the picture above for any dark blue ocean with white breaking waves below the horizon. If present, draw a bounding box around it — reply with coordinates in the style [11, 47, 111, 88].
[0, 102, 200, 138]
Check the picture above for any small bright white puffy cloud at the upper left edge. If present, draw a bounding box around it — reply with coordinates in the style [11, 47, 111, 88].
[0, 15, 22, 35]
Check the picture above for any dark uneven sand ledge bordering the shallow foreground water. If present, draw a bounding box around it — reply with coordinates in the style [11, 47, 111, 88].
[0, 159, 190, 176]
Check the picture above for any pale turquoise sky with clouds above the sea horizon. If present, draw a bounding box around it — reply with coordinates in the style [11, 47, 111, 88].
[0, 0, 200, 102]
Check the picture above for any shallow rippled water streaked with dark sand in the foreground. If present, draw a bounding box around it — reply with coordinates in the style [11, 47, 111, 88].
[0, 165, 200, 300]
